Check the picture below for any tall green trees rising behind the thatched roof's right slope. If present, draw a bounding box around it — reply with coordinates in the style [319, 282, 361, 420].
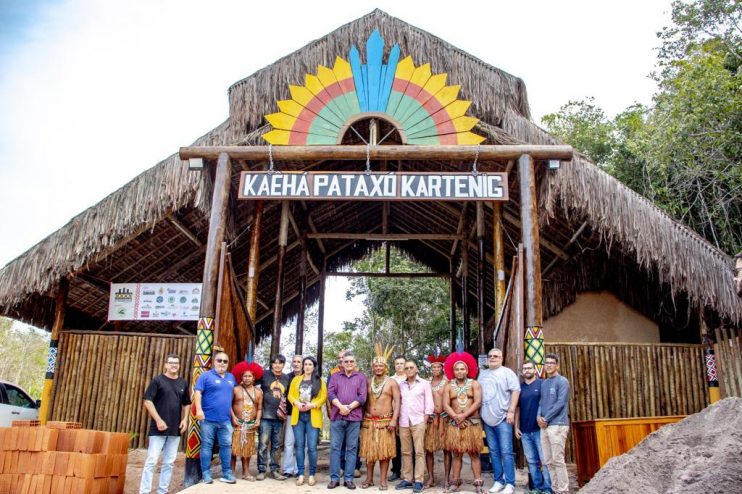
[543, 0, 742, 254]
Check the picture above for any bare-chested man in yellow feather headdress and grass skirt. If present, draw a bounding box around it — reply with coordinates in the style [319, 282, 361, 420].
[360, 343, 400, 491]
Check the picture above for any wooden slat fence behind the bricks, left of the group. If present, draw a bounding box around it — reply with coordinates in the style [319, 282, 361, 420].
[52, 331, 196, 448]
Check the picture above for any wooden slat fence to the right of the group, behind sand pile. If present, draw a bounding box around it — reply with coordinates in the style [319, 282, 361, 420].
[546, 342, 708, 462]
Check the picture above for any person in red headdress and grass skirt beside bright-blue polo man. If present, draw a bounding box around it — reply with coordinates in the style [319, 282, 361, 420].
[232, 361, 263, 481]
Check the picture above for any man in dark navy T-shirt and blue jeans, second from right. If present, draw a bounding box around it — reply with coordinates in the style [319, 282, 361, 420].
[515, 360, 551, 494]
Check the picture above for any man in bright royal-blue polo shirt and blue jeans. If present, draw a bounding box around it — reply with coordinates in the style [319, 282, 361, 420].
[193, 351, 236, 484]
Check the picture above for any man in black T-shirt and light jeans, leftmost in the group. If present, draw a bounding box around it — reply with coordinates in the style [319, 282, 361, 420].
[139, 353, 191, 494]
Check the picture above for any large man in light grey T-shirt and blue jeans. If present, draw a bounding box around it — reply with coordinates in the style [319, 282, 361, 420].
[477, 348, 520, 494]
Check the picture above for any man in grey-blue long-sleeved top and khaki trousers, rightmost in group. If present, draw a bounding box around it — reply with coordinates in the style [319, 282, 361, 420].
[536, 353, 569, 494]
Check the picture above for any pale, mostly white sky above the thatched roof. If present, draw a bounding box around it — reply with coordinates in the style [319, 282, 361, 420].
[0, 0, 670, 332]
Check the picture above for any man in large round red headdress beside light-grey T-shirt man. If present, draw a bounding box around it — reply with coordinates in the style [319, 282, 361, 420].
[443, 350, 484, 494]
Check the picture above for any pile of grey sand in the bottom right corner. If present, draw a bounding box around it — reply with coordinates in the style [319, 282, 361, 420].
[580, 398, 742, 494]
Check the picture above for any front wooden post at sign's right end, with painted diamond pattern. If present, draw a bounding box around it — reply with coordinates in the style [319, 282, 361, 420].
[518, 154, 544, 376]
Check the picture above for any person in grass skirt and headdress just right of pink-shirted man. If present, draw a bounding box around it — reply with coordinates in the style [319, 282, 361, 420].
[425, 352, 451, 487]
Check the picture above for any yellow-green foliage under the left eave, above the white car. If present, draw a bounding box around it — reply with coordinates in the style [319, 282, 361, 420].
[0, 317, 49, 399]
